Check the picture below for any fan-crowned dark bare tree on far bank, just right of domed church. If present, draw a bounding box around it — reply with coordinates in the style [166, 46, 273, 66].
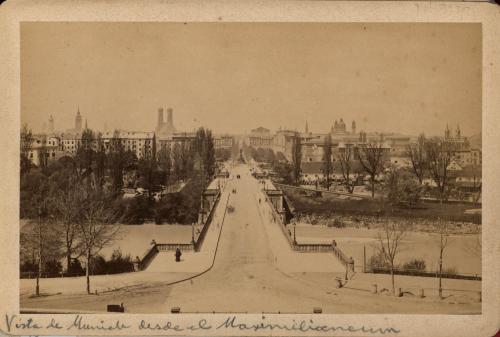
[356, 141, 384, 198]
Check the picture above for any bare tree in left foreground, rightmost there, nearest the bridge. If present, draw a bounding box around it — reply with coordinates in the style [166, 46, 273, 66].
[78, 187, 120, 294]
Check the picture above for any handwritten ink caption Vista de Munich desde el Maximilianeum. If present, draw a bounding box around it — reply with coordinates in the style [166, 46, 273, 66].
[5, 314, 400, 335]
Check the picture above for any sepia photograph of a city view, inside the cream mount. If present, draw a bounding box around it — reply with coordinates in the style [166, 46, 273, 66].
[15, 22, 482, 316]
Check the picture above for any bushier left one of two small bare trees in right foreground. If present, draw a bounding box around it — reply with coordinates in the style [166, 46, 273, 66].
[377, 221, 408, 294]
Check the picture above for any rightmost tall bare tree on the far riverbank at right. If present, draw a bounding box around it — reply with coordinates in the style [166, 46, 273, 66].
[425, 138, 452, 202]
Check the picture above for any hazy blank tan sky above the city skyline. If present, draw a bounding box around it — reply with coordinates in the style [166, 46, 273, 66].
[21, 23, 481, 135]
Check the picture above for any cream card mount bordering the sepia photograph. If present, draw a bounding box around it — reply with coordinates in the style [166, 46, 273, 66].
[0, 1, 500, 336]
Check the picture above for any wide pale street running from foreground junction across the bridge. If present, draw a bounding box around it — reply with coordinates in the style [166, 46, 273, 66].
[21, 164, 480, 313]
